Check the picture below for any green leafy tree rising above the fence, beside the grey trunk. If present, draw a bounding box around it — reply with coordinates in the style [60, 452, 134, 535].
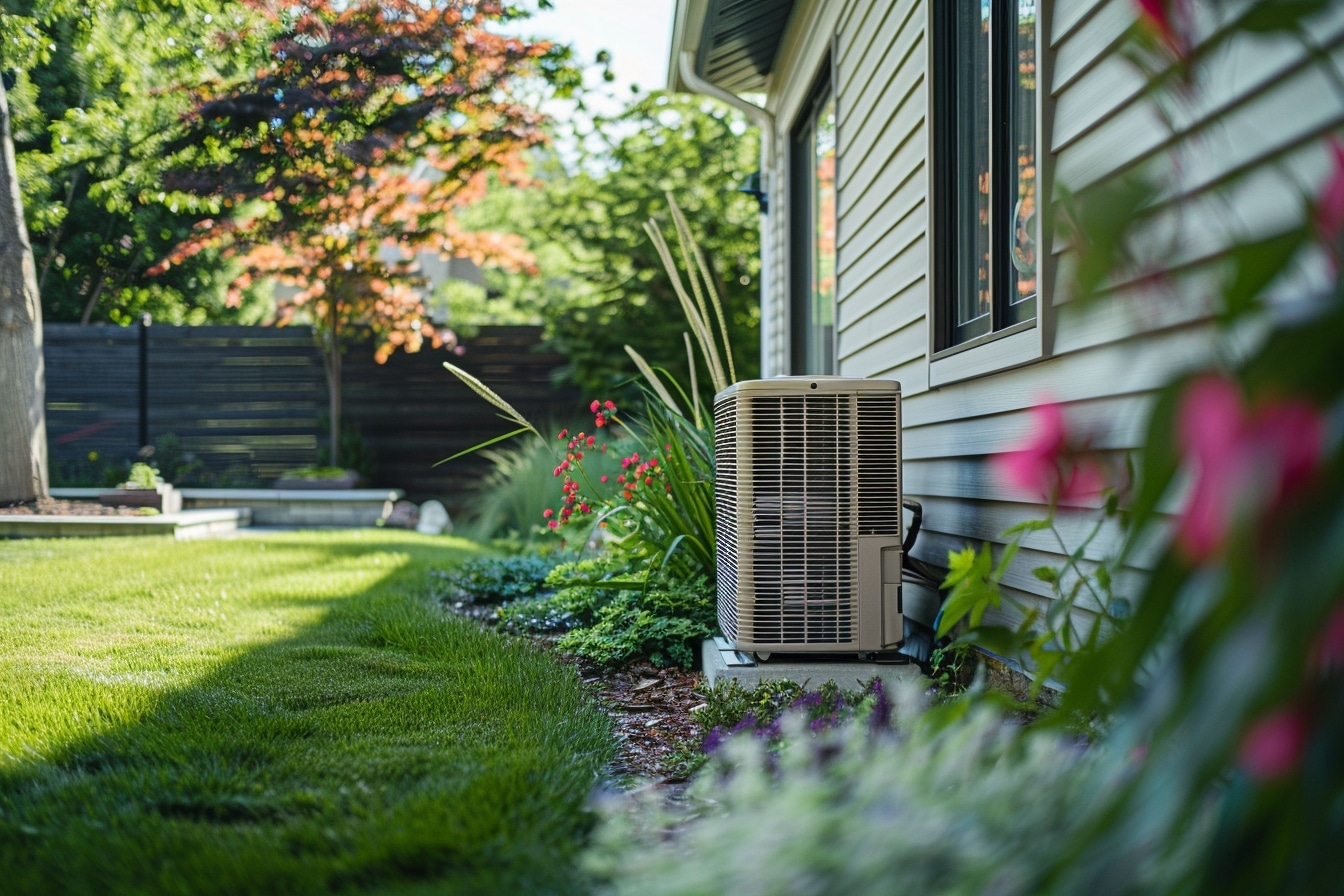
[0, 0, 270, 324]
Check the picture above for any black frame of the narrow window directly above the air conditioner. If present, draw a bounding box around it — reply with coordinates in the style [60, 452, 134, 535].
[789, 54, 840, 376]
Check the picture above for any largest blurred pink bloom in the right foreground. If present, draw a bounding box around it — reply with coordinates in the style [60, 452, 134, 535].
[1176, 376, 1325, 563]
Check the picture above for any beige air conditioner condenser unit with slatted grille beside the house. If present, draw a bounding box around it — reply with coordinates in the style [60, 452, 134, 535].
[714, 376, 903, 656]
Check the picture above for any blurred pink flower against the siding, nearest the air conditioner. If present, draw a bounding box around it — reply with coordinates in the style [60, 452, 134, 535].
[995, 402, 1106, 502]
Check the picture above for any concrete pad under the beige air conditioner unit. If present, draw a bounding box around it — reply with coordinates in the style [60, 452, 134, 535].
[700, 638, 923, 689]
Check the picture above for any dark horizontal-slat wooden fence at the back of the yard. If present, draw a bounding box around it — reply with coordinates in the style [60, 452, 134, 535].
[44, 324, 578, 508]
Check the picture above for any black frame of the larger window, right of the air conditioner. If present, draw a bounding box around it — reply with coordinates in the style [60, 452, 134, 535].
[930, 0, 1042, 355]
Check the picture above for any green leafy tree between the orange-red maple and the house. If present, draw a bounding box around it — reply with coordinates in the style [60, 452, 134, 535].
[465, 93, 761, 400]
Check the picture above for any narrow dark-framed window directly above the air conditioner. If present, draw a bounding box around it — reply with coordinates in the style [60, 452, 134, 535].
[789, 63, 836, 373]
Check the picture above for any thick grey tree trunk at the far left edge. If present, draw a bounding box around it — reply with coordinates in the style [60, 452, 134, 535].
[0, 77, 47, 504]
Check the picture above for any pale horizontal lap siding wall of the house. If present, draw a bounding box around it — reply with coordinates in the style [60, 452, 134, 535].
[762, 0, 1344, 623]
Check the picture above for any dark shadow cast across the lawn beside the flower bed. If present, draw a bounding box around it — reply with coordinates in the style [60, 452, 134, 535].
[0, 536, 609, 893]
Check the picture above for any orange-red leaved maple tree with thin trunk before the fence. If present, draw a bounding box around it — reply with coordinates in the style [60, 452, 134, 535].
[155, 0, 573, 463]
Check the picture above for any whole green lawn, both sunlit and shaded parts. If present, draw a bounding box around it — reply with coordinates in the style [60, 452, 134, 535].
[0, 531, 610, 893]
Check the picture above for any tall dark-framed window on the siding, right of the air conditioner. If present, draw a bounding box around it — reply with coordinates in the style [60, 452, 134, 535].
[931, 0, 1038, 352]
